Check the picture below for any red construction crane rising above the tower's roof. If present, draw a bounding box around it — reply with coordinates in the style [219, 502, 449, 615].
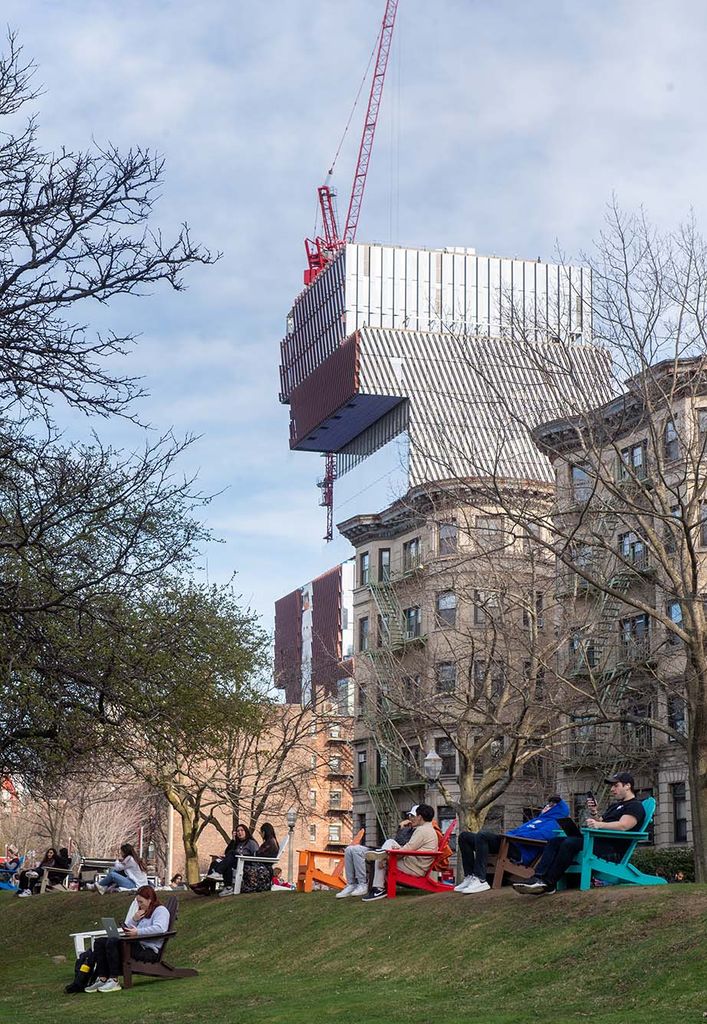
[304, 0, 399, 285]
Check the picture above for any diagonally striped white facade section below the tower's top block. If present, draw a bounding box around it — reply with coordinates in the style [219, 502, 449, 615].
[352, 329, 611, 485]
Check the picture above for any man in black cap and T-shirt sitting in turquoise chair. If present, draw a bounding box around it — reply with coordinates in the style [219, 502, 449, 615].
[513, 771, 646, 896]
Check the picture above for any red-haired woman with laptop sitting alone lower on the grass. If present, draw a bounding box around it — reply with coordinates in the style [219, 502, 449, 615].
[84, 886, 169, 992]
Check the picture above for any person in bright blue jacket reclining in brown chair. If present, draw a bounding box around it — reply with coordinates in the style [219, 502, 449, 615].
[454, 794, 570, 896]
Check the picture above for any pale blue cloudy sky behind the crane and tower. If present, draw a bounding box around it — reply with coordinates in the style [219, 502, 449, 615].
[9, 0, 707, 626]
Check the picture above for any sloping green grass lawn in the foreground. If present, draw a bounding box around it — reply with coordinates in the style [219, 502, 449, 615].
[0, 885, 707, 1024]
